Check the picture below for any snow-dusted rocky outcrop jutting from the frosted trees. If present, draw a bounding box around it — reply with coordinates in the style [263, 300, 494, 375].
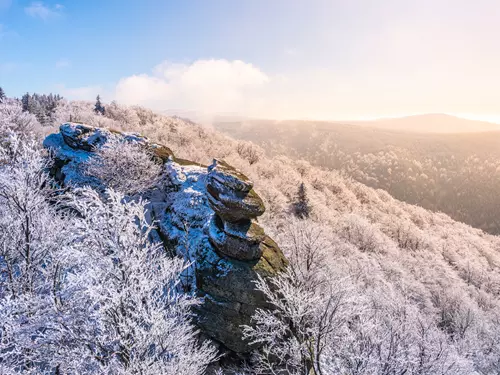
[44, 123, 287, 353]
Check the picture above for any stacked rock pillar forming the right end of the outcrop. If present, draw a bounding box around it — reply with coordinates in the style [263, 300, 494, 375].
[197, 160, 287, 353]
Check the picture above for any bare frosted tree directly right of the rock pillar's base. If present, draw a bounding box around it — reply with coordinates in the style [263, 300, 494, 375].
[245, 222, 350, 375]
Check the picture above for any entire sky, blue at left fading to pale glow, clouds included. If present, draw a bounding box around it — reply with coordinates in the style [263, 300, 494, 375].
[0, 0, 500, 121]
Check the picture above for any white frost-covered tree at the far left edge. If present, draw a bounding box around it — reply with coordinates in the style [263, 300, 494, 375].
[0, 138, 81, 373]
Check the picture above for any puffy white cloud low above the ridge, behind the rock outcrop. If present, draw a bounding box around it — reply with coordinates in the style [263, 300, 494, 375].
[115, 59, 269, 113]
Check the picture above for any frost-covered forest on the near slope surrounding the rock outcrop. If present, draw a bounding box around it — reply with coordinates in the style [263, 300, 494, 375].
[0, 92, 500, 375]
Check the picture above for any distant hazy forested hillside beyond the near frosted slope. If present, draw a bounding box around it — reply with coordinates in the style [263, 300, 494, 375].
[215, 120, 500, 234]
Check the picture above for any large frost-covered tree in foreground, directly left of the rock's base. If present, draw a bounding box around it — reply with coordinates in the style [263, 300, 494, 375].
[65, 189, 215, 375]
